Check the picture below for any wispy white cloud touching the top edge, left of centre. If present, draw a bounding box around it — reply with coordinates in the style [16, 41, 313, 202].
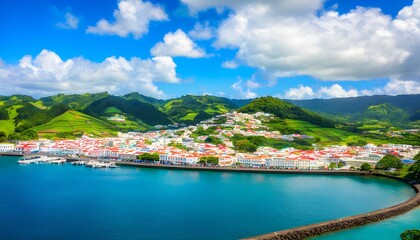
[86, 0, 168, 39]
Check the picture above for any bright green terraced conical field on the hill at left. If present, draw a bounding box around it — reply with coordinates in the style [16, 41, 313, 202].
[33, 111, 116, 136]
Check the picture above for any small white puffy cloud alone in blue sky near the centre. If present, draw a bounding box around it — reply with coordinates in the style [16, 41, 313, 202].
[150, 29, 206, 58]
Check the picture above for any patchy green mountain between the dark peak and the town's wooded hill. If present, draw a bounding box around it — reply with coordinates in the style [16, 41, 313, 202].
[161, 95, 238, 123]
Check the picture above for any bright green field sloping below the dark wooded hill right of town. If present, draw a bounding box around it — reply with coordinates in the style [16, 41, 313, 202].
[285, 119, 382, 144]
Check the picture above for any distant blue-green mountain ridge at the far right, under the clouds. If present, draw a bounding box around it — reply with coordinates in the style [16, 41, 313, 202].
[285, 94, 420, 126]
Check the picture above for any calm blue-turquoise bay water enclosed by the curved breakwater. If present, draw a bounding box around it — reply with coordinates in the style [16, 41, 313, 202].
[0, 157, 414, 239]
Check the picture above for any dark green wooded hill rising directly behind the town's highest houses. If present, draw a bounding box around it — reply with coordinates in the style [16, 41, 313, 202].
[238, 97, 335, 128]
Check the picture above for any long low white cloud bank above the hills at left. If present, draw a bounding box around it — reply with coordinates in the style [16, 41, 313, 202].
[0, 50, 180, 98]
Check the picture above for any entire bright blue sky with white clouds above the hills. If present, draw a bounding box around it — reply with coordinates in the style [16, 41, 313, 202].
[0, 0, 420, 99]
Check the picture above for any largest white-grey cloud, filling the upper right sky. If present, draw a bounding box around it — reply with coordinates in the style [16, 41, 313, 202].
[182, 0, 420, 85]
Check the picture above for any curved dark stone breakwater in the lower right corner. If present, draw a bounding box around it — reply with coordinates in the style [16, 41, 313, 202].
[246, 183, 420, 240]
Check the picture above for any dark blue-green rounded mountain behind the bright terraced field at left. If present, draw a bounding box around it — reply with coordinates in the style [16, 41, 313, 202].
[83, 96, 172, 126]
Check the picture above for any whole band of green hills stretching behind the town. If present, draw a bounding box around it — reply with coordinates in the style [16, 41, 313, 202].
[0, 92, 420, 143]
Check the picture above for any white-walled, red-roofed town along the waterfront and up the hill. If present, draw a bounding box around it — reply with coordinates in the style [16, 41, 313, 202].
[0, 112, 419, 170]
